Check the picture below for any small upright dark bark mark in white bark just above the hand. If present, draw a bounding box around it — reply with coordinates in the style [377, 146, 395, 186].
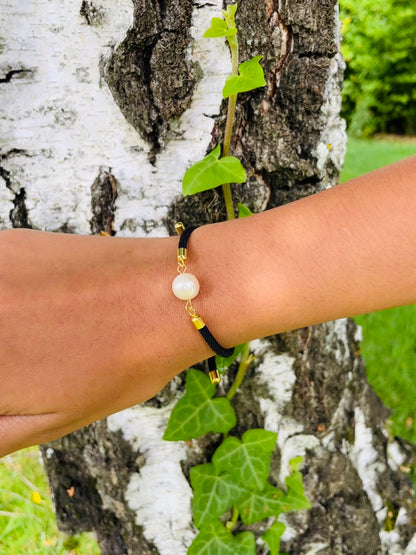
[90, 168, 118, 235]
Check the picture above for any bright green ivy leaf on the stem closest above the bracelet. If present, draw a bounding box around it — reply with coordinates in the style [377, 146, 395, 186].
[182, 145, 246, 195]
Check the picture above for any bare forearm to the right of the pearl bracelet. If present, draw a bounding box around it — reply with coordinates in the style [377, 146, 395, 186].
[190, 157, 416, 345]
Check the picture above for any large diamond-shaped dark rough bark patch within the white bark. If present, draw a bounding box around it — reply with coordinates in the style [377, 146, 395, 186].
[105, 0, 198, 162]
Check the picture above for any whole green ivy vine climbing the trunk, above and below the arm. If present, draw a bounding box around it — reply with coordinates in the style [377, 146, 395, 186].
[163, 4, 310, 555]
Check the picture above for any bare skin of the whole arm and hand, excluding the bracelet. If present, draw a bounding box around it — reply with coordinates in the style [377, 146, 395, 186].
[0, 157, 416, 456]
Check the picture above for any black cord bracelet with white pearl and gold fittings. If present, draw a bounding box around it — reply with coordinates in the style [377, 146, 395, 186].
[172, 222, 234, 384]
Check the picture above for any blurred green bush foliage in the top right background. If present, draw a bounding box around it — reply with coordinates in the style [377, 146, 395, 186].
[340, 0, 416, 136]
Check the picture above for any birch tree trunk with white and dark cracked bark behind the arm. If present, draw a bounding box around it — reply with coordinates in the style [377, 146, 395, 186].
[0, 0, 416, 555]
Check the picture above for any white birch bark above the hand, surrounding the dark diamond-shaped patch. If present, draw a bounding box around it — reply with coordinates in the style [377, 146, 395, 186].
[0, 0, 230, 236]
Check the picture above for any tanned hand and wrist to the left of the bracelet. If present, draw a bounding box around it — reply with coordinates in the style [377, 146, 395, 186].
[0, 230, 208, 456]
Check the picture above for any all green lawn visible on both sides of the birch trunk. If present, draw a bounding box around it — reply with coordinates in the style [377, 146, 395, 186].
[0, 134, 416, 555]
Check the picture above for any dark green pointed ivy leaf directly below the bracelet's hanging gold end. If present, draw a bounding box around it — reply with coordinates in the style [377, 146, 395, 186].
[163, 368, 236, 441]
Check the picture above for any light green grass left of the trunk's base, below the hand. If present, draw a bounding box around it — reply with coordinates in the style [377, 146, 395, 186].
[0, 448, 100, 555]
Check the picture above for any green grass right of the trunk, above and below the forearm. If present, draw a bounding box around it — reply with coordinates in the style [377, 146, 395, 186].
[341, 138, 416, 442]
